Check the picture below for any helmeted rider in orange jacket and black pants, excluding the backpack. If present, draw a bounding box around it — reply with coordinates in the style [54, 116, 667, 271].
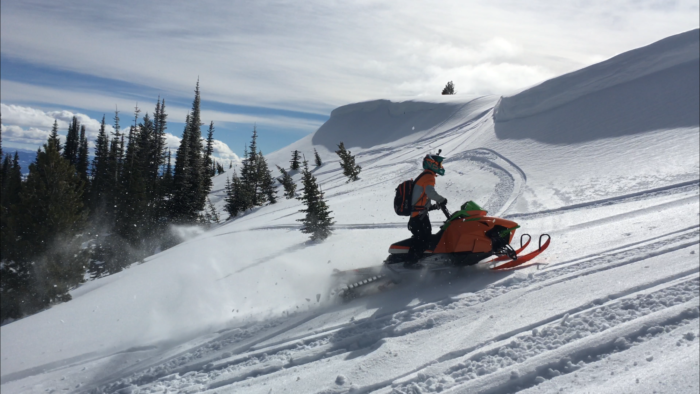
[406, 149, 447, 265]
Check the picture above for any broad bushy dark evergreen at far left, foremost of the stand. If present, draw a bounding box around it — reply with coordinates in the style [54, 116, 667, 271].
[10, 142, 88, 312]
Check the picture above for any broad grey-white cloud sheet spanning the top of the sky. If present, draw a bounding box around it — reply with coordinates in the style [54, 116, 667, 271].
[0, 0, 698, 114]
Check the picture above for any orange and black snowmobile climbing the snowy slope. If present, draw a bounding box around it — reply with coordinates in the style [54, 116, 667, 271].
[333, 201, 551, 299]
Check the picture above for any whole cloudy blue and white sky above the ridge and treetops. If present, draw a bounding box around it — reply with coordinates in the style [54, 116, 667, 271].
[0, 0, 700, 160]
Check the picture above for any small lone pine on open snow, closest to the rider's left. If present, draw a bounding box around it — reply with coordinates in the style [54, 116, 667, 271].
[297, 160, 334, 241]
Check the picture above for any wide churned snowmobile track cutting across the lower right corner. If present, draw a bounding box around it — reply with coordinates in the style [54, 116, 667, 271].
[391, 275, 700, 394]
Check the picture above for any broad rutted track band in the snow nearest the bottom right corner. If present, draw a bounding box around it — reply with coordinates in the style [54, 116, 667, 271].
[381, 274, 700, 393]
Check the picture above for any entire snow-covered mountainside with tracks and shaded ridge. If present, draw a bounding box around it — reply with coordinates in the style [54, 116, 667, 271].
[1, 30, 700, 393]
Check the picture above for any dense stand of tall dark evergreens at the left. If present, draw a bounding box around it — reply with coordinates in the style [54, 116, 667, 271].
[0, 82, 223, 321]
